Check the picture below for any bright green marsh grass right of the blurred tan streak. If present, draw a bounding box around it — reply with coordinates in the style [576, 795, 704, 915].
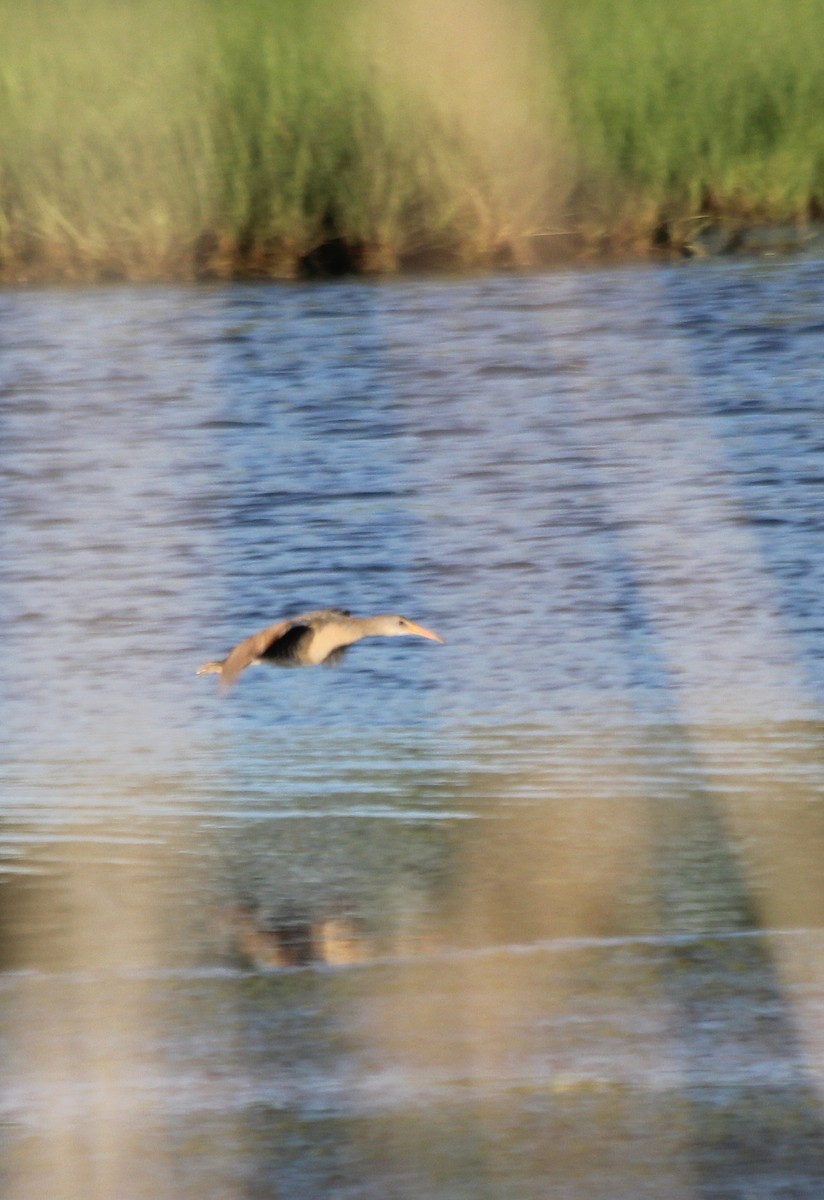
[545, 0, 824, 220]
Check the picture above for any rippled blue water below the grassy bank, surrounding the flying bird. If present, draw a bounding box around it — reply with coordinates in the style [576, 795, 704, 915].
[0, 260, 824, 1200]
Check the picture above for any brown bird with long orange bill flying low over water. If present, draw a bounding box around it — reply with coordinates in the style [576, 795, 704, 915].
[197, 608, 444, 688]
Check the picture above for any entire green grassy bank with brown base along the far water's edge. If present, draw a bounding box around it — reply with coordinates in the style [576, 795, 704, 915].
[0, 0, 824, 282]
